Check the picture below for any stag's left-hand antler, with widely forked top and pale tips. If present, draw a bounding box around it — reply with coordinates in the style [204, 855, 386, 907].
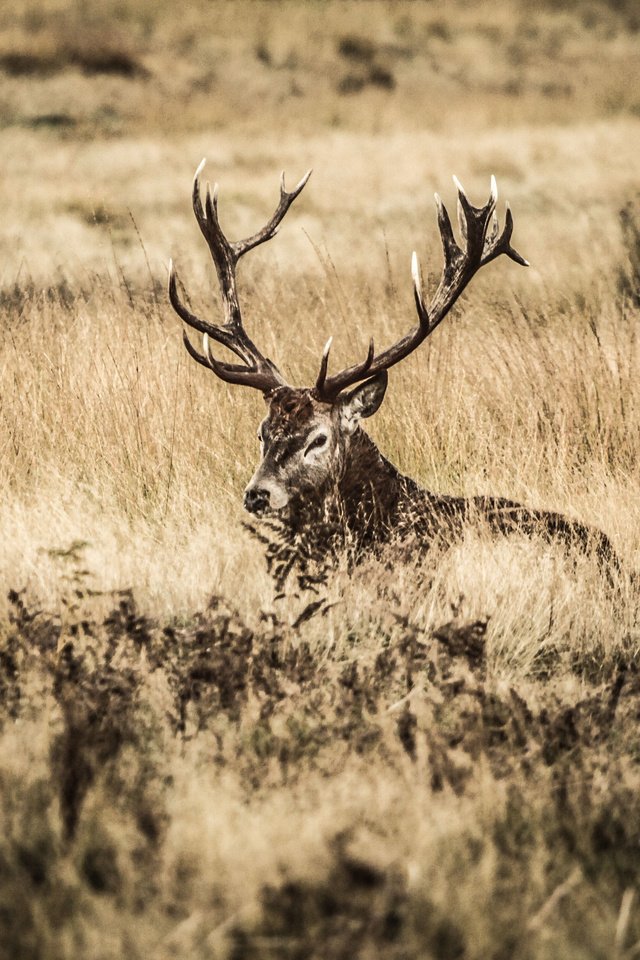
[169, 160, 311, 393]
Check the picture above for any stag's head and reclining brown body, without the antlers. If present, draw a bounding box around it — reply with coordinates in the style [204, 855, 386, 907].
[245, 386, 616, 563]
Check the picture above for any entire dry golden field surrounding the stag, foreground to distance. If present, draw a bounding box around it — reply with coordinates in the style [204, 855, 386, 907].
[0, 0, 640, 960]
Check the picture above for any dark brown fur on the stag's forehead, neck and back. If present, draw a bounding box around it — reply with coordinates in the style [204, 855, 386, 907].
[252, 388, 619, 578]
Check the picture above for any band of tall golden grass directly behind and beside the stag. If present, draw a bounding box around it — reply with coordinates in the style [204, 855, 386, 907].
[0, 197, 639, 606]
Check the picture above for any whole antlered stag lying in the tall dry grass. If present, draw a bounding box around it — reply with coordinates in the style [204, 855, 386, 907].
[169, 160, 619, 582]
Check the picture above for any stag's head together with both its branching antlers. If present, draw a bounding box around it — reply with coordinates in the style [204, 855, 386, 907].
[169, 160, 527, 515]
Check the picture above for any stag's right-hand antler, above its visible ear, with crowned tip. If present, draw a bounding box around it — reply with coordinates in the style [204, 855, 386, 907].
[315, 177, 529, 402]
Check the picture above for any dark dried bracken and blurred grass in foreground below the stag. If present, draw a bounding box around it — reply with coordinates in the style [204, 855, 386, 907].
[0, 545, 640, 960]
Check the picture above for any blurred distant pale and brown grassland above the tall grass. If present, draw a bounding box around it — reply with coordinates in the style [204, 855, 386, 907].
[0, 0, 640, 291]
